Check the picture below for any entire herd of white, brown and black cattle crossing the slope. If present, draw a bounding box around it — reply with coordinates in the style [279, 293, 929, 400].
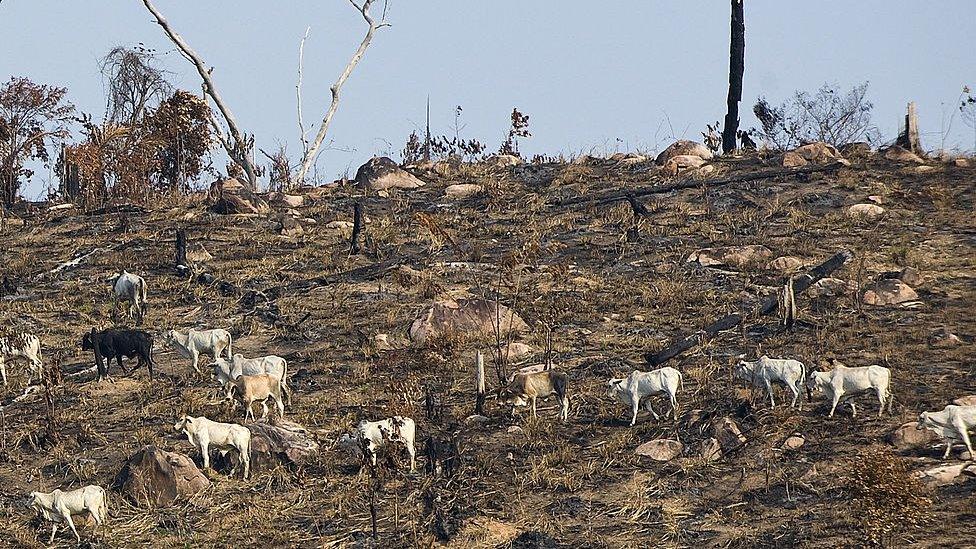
[0, 270, 976, 543]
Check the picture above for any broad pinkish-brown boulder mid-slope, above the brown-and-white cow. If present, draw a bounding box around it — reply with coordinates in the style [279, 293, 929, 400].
[409, 299, 529, 346]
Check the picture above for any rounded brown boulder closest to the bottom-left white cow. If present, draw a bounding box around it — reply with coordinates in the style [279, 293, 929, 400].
[113, 445, 210, 507]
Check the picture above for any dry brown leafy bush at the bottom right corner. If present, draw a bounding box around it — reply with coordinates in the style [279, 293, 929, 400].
[847, 445, 932, 547]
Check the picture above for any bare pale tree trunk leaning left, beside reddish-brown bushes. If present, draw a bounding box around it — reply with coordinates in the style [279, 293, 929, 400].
[142, 0, 258, 190]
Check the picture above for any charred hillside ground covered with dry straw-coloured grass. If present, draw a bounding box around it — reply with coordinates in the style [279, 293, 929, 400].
[0, 151, 976, 547]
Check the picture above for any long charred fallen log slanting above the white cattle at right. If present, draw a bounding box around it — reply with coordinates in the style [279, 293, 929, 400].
[644, 250, 854, 366]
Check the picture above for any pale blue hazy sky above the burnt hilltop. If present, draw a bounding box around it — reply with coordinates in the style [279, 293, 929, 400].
[0, 0, 976, 197]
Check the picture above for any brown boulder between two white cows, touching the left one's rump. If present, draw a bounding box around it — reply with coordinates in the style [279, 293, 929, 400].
[245, 419, 319, 471]
